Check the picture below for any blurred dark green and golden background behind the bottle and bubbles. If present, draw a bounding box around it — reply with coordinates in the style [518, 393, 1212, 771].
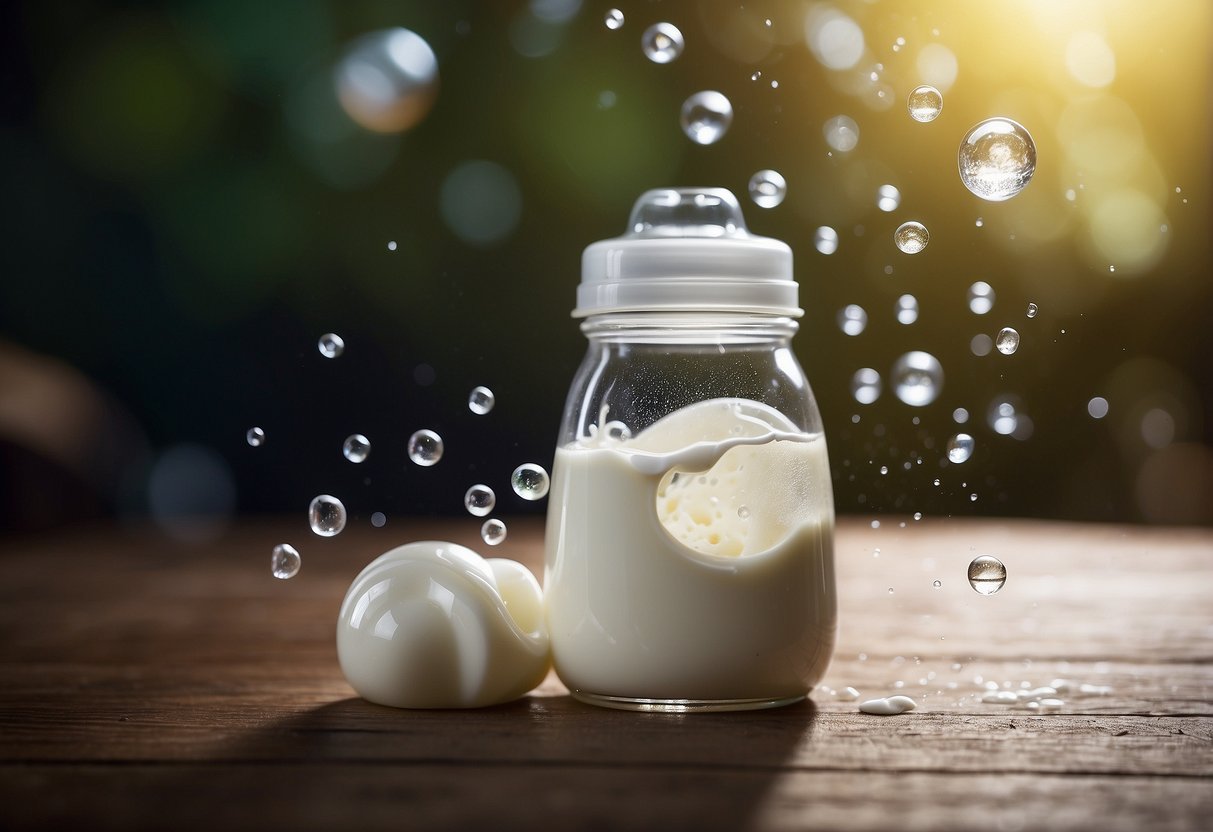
[0, 0, 1213, 537]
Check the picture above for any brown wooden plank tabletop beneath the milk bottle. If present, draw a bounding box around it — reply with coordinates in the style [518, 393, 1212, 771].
[0, 518, 1213, 832]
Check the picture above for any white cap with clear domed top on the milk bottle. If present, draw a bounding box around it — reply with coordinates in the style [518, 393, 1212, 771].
[573, 188, 804, 318]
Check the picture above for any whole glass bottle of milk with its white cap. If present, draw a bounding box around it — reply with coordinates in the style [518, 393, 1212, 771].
[545, 188, 837, 712]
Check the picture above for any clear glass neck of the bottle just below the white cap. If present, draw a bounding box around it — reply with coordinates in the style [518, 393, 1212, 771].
[581, 310, 799, 346]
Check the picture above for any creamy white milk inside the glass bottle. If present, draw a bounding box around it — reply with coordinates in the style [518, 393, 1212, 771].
[545, 399, 836, 701]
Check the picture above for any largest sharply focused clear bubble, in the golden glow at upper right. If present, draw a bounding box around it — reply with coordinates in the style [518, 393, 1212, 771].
[958, 119, 1036, 203]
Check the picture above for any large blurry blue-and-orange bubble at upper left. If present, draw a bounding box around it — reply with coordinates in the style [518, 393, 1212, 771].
[334, 28, 438, 133]
